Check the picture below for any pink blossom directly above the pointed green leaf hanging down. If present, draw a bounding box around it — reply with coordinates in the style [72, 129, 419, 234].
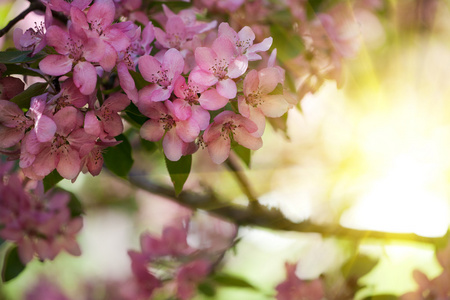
[138, 101, 200, 161]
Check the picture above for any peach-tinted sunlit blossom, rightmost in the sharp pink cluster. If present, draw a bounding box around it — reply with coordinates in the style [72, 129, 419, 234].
[238, 67, 296, 136]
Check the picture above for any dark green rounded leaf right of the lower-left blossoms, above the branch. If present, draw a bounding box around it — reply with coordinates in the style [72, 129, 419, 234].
[103, 134, 134, 178]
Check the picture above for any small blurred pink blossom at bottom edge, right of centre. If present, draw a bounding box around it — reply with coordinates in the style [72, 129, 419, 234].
[275, 263, 324, 300]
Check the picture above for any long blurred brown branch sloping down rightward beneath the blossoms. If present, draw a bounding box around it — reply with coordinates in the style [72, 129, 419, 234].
[129, 172, 447, 245]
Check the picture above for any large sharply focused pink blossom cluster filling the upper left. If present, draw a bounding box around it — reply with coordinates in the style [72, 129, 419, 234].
[0, 0, 296, 180]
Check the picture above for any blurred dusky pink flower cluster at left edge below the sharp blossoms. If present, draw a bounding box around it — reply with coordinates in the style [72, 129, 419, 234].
[0, 163, 83, 264]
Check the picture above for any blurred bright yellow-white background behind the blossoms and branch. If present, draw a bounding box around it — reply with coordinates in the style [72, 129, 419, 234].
[0, 0, 450, 299]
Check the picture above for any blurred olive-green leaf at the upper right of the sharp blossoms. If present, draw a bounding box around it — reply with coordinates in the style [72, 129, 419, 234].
[270, 23, 305, 63]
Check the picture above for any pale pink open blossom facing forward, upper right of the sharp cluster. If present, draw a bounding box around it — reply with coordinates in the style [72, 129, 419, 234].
[191, 36, 248, 99]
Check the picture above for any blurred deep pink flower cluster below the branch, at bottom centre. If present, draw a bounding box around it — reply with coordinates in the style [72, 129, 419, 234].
[122, 218, 236, 300]
